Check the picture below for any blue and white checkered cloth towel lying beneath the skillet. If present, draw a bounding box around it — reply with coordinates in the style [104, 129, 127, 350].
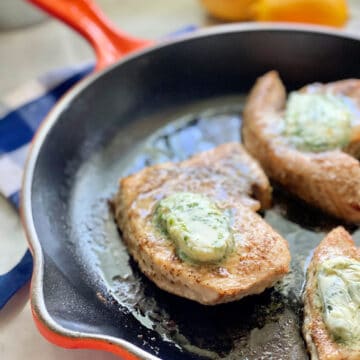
[0, 25, 196, 309]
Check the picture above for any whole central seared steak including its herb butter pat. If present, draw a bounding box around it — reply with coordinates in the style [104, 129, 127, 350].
[114, 143, 290, 305]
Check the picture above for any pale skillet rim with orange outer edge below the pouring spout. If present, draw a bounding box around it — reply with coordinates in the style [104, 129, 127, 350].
[20, 22, 360, 360]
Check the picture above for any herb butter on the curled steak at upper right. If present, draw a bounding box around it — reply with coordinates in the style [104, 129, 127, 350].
[284, 92, 351, 152]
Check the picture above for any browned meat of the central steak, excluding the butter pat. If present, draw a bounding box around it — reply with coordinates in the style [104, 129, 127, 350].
[114, 143, 290, 304]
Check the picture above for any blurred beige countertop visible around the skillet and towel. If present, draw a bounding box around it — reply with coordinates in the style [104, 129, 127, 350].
[0, 0, 360, 360]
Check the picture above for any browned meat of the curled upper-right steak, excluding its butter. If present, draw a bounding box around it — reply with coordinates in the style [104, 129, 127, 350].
[242, 71, 360, 223]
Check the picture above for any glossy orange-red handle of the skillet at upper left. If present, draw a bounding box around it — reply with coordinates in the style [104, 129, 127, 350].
[28, 0, 152, 71]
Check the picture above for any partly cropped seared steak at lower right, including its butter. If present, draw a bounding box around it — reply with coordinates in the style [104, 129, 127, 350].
[303, 227, 360, 360]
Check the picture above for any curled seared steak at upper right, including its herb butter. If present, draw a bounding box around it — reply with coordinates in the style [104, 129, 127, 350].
[242, 71, 360, 222]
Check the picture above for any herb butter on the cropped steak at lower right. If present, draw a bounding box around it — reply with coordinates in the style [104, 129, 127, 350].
[318, 256, 360, 350]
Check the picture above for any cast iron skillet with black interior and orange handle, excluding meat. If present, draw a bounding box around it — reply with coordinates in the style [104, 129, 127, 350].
[22, 0, 360, 360]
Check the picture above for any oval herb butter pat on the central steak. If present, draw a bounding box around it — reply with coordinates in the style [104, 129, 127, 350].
[154, 192, 234, 263]
